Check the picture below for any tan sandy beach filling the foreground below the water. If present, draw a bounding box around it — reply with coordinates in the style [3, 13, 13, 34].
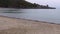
[0, 16, 60, 34]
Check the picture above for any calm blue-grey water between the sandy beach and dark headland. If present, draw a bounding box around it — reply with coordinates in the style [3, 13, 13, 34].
[0, 8, 60, 23]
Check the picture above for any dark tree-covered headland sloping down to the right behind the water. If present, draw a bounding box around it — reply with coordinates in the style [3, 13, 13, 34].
[0, 0, 55, 9]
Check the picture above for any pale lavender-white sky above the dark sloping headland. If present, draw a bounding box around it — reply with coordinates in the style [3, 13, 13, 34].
[26, 0, 60, 8]
